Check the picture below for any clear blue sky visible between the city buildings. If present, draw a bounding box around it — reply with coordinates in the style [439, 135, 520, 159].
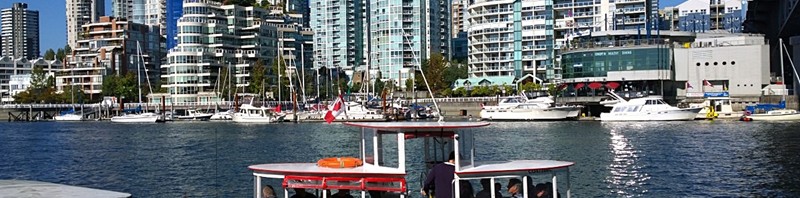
[0, 0, 685, 55]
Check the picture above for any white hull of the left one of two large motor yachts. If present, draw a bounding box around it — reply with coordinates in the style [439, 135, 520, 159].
[481, 108, 572, 120]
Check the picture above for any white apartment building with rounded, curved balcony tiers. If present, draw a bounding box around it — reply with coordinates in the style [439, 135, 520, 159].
[161, 0, 278, 102]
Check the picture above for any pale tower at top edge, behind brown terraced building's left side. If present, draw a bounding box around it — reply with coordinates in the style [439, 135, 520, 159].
[66, 0, 106, 49]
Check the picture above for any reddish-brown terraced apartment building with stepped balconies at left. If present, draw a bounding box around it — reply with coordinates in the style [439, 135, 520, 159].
[56, 16, 162, 96]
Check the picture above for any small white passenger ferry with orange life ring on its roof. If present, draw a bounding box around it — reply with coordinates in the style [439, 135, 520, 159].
[248, 122, 574, 198]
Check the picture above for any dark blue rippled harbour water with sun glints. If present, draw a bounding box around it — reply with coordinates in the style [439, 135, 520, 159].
[0, 121, 800, 197]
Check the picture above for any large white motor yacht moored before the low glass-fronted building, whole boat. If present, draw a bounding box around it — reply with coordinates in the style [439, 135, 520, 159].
[600, 96, 703, 121]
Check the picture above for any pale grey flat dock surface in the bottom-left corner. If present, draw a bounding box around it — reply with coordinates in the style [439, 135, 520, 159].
[0, 180, 131, 198]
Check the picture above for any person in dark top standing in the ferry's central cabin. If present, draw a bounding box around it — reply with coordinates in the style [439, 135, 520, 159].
[422, 152, 456, 198]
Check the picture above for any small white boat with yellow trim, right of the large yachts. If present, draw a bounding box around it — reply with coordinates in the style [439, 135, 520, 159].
[689, 97, 742, 119]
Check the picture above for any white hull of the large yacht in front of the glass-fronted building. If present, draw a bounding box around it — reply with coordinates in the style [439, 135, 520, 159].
[600, 108, 701, 121]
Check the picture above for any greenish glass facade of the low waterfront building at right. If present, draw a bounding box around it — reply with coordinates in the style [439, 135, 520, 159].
[561, 47, 672, 79]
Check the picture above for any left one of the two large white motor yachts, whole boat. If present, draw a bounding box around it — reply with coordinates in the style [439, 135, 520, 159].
[480, 93, 581, 120]
